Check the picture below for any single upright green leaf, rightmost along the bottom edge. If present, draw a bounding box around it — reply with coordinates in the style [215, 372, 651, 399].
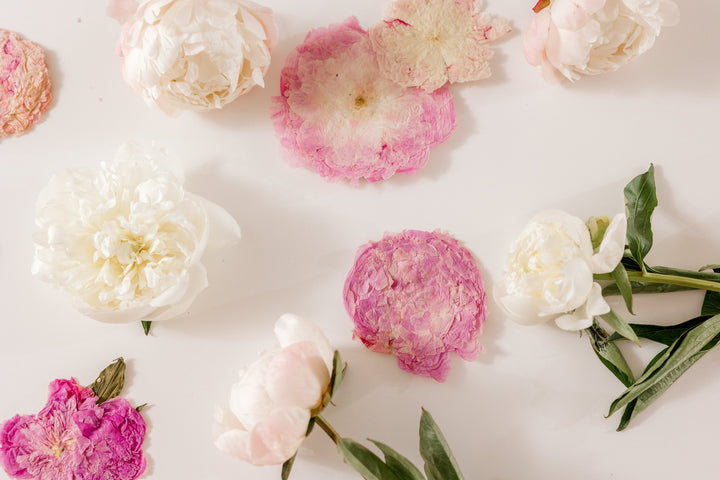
[420, 409, 463, 480]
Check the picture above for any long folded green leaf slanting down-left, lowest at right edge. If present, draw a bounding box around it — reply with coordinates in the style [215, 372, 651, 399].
[608, 315, 720, 416]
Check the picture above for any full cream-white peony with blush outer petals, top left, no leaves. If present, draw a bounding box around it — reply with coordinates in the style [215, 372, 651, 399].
[118, 0, 277, 115]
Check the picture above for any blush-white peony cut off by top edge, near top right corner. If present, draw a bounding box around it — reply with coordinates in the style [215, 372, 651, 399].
[524, 0, 679, 81]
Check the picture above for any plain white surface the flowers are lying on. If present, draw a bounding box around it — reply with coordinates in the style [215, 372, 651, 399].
[0, 0, 720, 480]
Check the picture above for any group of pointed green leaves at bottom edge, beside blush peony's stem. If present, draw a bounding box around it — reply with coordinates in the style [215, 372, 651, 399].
[337, 409, 464, 480]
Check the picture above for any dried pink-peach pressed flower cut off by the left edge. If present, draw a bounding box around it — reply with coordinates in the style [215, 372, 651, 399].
[0, 29, 52, 139]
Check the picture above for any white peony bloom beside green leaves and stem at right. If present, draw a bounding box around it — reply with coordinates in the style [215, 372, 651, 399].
[496, 210, 627, 330]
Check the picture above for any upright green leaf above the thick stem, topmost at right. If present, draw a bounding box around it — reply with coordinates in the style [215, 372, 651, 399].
[624, 165, 657, 271]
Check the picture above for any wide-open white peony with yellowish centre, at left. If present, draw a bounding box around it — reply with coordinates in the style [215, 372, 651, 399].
[32, 144, 240, 323]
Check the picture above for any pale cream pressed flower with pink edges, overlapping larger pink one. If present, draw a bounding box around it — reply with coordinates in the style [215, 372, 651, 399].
[369, 0, 510, 92]
